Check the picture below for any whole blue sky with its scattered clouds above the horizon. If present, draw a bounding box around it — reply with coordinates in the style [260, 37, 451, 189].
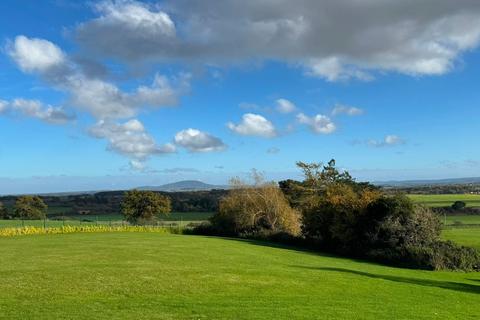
[0, 0, 480, 194]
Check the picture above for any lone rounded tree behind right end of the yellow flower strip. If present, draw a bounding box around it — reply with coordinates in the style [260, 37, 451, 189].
[122, 190, 171, 224]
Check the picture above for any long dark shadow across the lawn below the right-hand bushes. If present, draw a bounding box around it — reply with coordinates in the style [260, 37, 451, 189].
[294, 266, 480, 294]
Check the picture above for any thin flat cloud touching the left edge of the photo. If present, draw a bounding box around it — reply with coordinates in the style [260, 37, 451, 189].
[0, 99, 76, 124]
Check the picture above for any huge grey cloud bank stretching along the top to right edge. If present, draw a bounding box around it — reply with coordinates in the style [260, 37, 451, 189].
[72, 0, 480, 81]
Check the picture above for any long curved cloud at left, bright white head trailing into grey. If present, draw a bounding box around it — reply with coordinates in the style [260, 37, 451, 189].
[9, 36, 190, 120]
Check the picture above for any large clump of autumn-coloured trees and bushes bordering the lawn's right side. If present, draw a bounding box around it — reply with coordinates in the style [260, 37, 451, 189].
[195, 160, 480, 270]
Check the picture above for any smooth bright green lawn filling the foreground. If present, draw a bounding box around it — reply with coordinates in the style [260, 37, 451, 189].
[0, 233, 480, 319]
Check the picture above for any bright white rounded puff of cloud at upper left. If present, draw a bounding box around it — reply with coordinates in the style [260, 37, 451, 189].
[7, 35, 66, 72]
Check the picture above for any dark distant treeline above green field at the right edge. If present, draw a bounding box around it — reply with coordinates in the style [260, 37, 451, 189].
[383, 184, 480, 194]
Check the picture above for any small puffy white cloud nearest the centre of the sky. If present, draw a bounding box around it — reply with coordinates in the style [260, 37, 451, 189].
[227, 113, 277, 138]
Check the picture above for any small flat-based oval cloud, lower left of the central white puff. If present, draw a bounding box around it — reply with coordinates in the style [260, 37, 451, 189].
[174, 128, 226, 152]
